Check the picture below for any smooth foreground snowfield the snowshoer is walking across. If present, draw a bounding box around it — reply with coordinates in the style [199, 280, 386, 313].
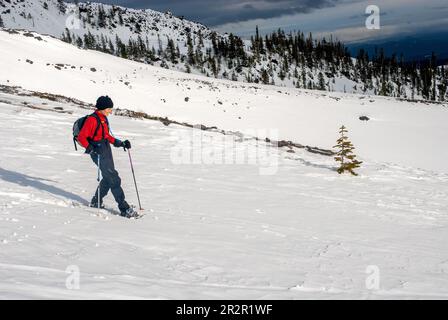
[0, 87, 448, 299]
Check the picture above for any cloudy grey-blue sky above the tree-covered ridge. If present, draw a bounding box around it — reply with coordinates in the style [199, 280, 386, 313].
[75, 0, 448, 42]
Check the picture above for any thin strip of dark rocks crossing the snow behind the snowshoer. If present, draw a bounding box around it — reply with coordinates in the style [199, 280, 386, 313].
[0, 84, 334, 157]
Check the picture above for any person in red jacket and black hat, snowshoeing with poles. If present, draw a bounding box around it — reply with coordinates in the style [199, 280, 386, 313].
[78, 96, 137, 218]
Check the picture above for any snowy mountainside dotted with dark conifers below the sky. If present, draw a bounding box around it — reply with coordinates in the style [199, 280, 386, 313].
[0, 0, 448, 101]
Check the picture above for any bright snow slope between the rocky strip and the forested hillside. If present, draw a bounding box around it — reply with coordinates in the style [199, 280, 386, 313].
[0, 31, 448, 172]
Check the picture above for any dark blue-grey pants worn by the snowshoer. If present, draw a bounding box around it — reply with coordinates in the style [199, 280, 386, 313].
[90, 140, 129, 212]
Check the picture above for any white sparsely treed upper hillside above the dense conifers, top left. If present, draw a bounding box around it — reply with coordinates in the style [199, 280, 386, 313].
[0, 0, 212, 49]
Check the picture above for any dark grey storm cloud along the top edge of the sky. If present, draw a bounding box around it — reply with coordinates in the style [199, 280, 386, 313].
[76, 0, 344, 26]
